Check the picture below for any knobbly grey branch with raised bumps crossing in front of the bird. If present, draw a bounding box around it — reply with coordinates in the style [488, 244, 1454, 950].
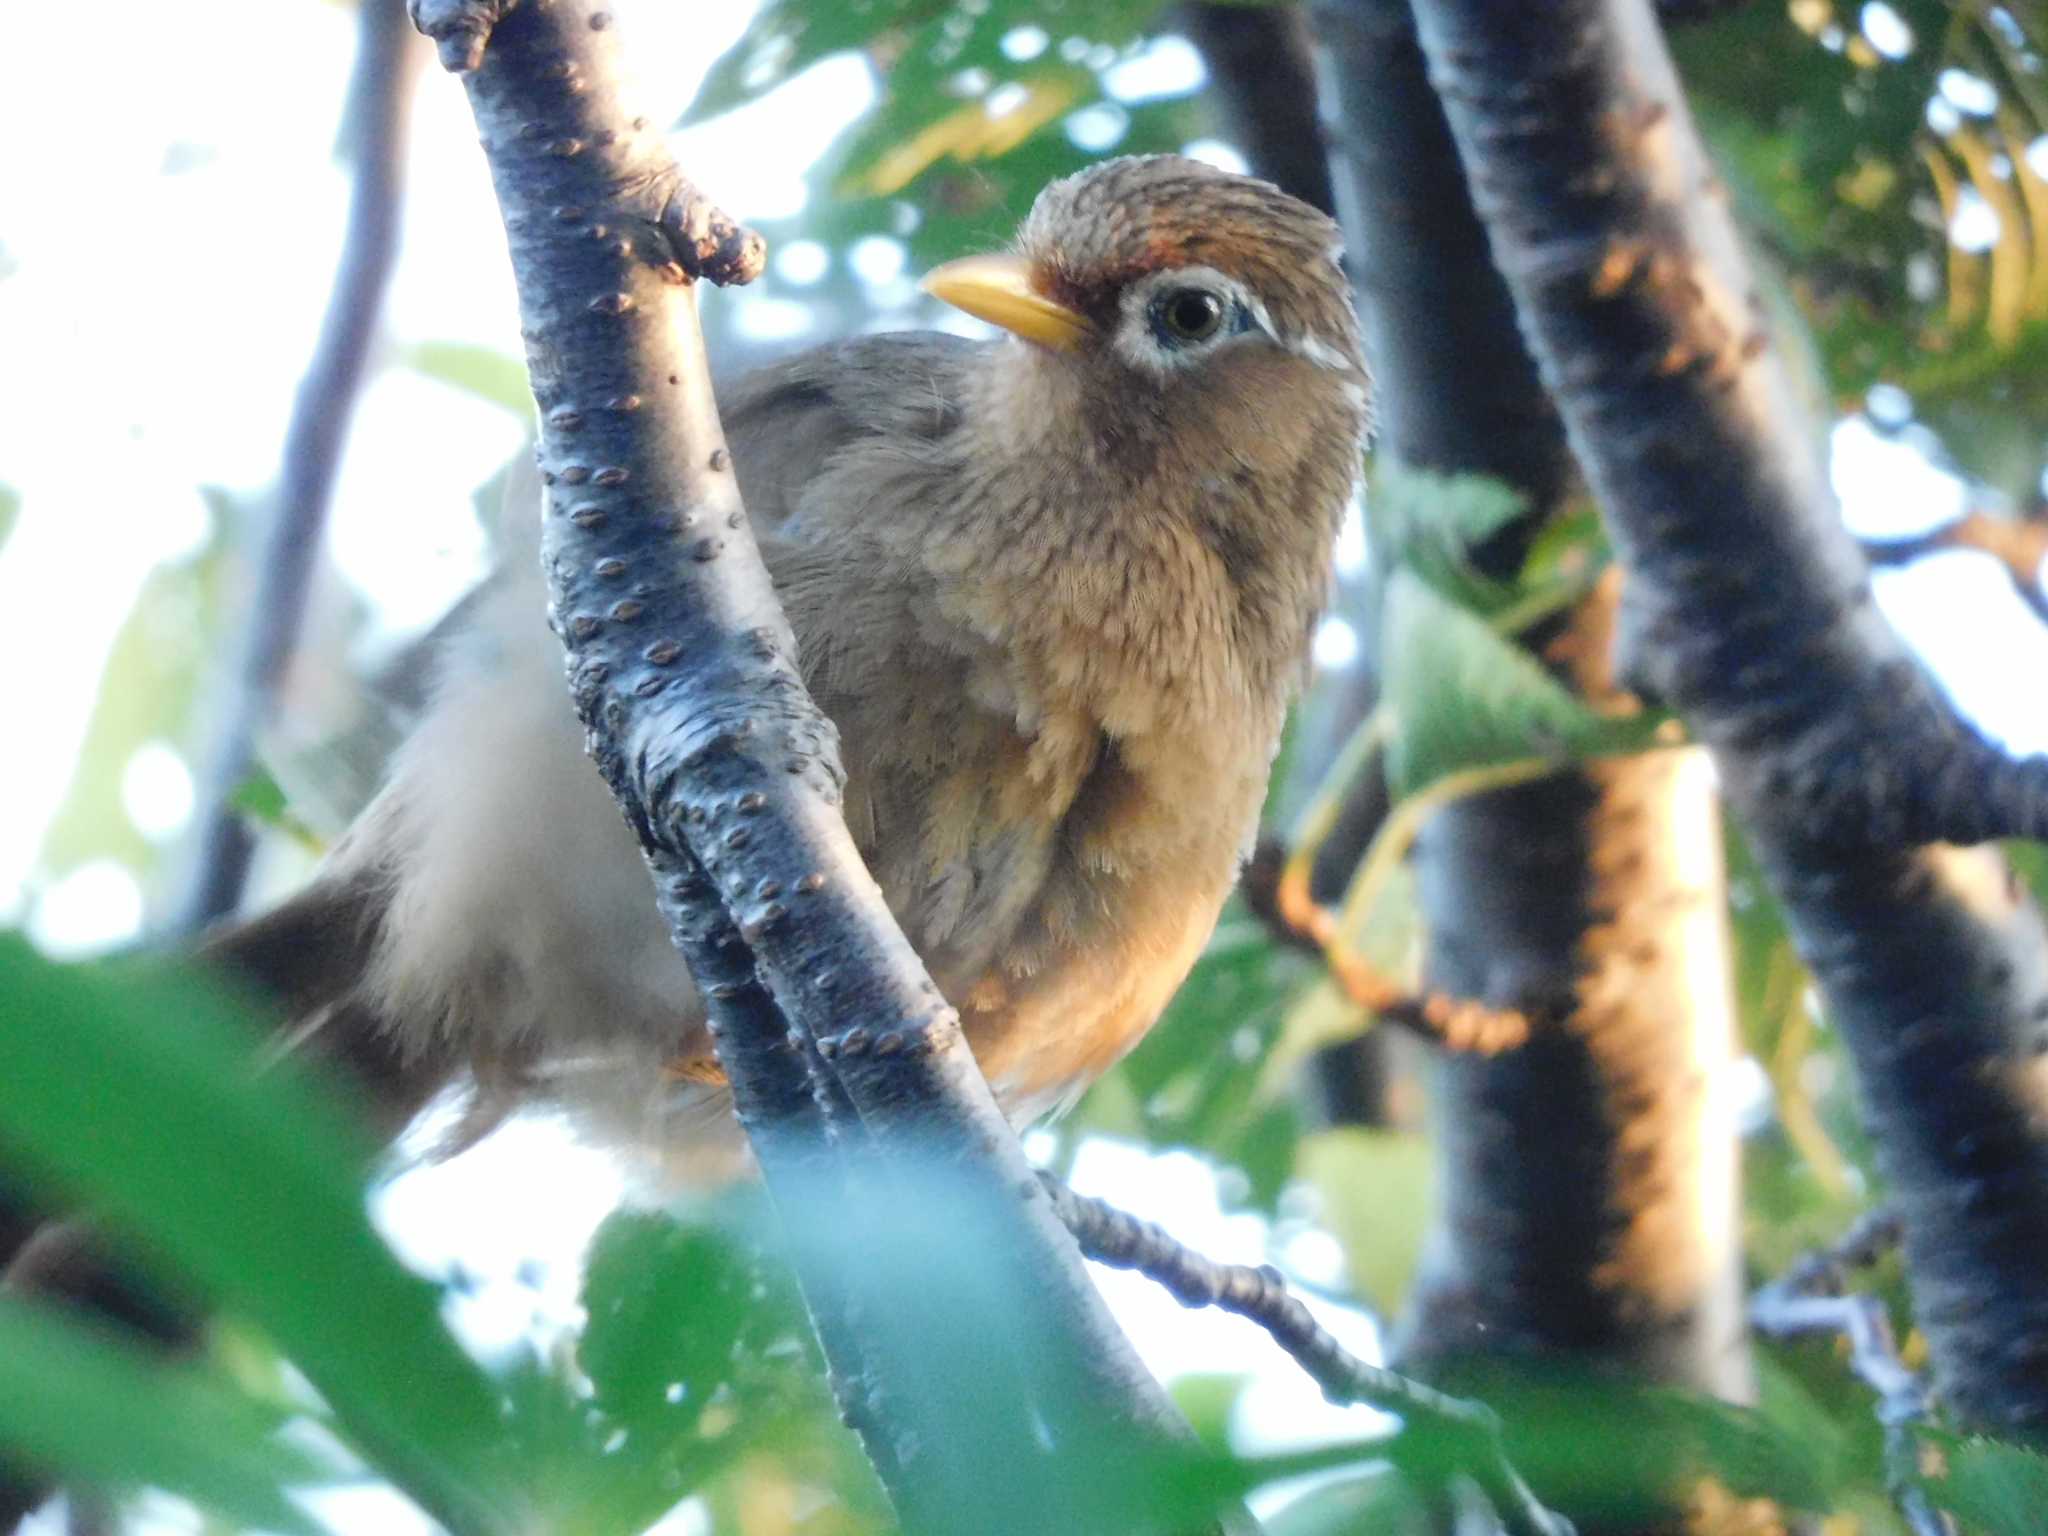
[414, 0, 1184, 1530]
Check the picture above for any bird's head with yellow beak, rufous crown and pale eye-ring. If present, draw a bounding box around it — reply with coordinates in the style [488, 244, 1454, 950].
[924, 156, 1368, 436]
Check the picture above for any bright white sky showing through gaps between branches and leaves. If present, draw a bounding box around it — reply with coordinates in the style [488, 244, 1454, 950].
[0, 0, 2048, 1536]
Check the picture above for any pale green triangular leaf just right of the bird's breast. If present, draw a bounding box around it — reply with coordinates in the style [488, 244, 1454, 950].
[1380, 569, 1663, 797]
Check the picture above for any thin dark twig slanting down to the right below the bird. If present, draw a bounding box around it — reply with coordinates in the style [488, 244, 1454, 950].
[1038, 1174, 1571, 1536]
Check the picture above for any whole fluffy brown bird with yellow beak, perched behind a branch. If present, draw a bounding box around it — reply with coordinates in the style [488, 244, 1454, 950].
[213, 156, 1368, 1176]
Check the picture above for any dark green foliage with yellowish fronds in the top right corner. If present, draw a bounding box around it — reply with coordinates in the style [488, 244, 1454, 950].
[1673, 0, 2048, 506]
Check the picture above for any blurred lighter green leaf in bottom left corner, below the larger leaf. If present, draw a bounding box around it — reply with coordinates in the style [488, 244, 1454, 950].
[0, 1296, 334, 1532]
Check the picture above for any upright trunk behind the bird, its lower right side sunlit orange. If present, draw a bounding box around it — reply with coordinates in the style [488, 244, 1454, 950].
[1315, 0, 1749, 1399]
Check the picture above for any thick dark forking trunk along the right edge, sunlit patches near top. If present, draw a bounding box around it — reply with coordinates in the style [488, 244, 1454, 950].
[1415, 0, 2048, 1436]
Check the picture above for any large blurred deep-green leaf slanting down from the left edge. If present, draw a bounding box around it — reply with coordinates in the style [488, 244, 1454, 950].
[0, 936, 516, 1530]
